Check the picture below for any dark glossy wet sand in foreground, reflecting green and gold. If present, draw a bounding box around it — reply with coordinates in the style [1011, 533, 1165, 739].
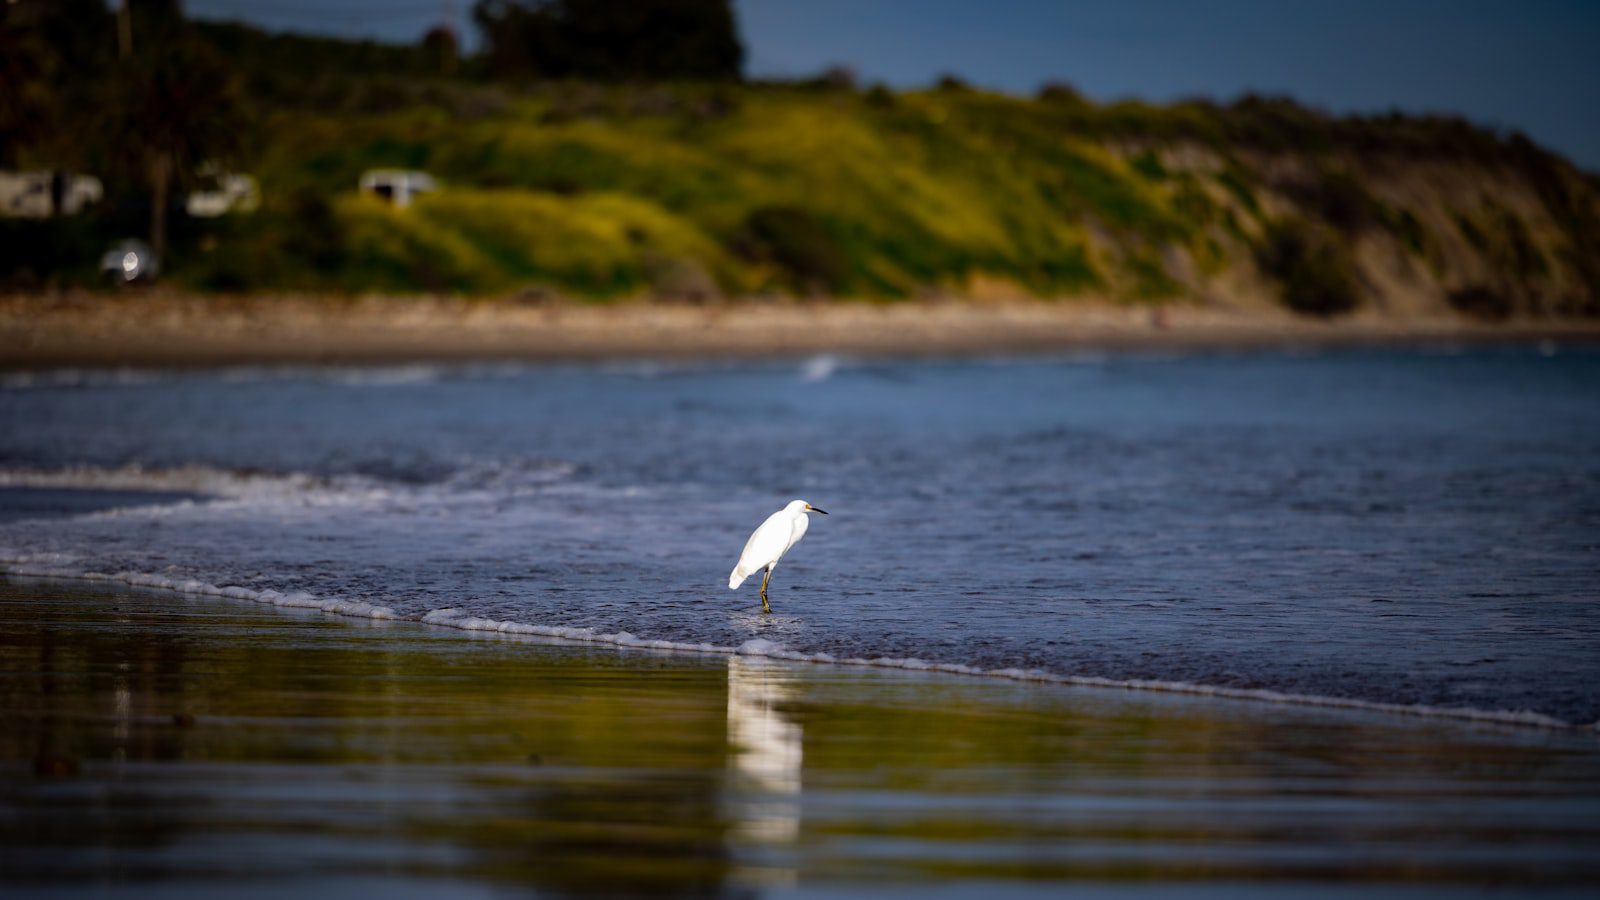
[9, 578, 1600, 897]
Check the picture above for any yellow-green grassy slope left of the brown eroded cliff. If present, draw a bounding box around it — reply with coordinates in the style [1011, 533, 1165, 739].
[197, 88, 1164, 296]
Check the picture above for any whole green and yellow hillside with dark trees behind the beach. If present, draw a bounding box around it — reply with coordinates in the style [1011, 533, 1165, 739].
[0, 0, 1600, 319]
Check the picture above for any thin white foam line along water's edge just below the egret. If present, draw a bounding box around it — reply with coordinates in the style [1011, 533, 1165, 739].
[0, 554, 1600, 732]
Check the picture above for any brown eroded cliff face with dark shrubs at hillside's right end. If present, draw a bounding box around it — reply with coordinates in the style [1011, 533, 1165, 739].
[1107, 143, 1600, 320]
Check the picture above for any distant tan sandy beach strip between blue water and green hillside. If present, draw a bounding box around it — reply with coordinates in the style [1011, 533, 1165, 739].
[0, 291, 1600, 372]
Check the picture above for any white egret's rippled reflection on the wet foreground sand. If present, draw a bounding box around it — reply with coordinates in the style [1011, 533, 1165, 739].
[728, 646, 803, 846]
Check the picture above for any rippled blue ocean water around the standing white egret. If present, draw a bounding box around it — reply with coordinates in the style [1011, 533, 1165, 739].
[0, 346, 1600, 727]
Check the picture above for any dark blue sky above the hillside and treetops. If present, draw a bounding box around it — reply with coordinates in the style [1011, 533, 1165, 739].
[184, 0, 1600, 171]
